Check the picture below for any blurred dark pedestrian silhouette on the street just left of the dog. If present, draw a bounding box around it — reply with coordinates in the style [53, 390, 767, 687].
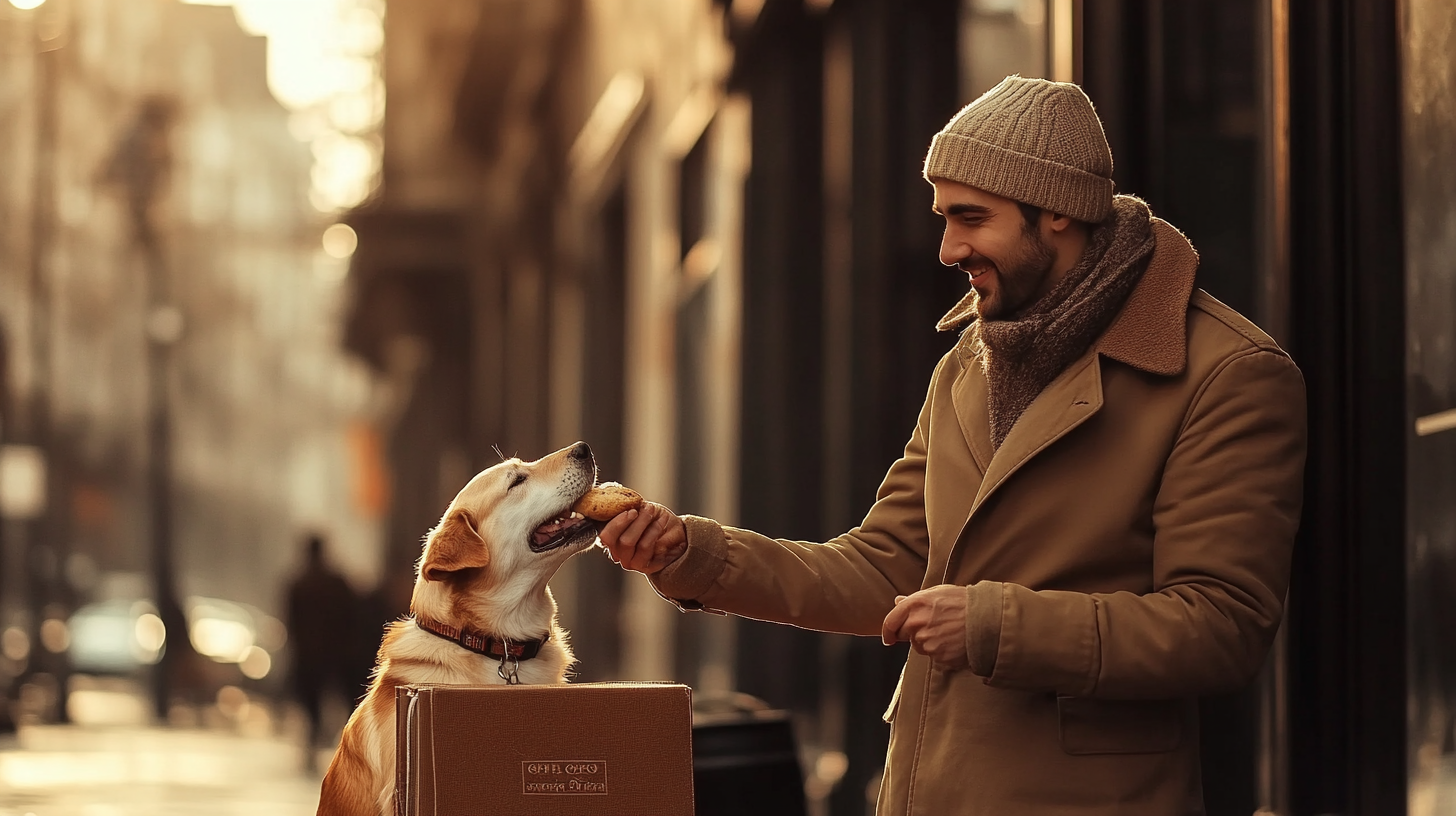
[285, 533, 364, 768]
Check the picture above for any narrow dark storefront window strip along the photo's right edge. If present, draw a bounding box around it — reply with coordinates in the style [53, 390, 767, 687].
[1404, 0, 1456, 816]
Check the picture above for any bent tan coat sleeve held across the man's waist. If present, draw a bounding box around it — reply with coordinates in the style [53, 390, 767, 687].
[967, 350, 1306, 698]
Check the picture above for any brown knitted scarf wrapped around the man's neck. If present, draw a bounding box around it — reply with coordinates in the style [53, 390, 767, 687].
[952, 195, 1155, 449]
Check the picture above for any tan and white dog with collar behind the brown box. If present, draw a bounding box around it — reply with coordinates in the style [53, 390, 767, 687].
[317, 443, 603, 816]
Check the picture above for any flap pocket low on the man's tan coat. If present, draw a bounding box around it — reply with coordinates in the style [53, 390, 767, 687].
[1057, 697, 1184, 755]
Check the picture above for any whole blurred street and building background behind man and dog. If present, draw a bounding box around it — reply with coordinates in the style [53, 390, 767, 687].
[0, 0, 1456, 816]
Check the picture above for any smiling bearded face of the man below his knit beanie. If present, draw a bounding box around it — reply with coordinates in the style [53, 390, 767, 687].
[932, 179, 1056, 321]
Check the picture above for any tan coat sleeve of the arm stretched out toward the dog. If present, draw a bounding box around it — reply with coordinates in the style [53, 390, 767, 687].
[652, 358, 945, 635]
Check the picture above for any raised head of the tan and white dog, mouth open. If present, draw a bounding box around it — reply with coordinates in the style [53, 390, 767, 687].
[419, 443, 603, 583]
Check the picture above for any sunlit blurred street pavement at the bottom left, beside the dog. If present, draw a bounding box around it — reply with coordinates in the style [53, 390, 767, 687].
[0, 687, 319, 816]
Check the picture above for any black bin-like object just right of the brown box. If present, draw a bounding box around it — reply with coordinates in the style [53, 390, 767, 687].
[693, 694, 807, 816]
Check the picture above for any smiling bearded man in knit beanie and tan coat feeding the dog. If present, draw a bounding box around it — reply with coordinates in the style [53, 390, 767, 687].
[601, 77, 1306, 816]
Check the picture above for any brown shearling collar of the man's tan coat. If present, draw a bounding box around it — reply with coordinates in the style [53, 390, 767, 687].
[935, 217, 1198, 376]
